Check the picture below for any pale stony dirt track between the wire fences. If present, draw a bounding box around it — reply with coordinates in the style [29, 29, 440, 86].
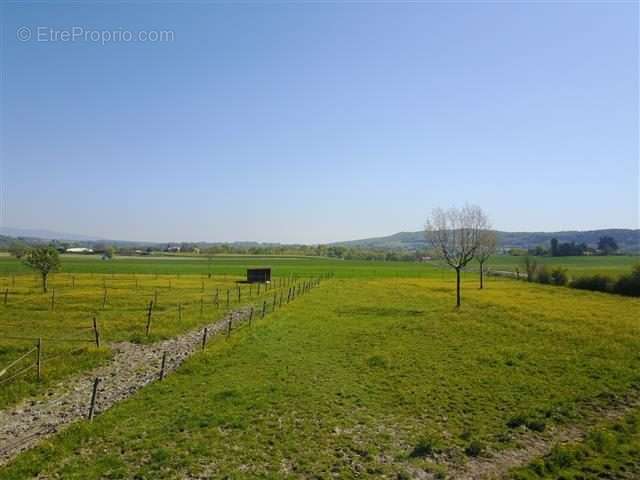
[0, 307, 250, 465]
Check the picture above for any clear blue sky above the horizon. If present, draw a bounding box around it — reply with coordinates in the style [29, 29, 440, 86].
[0, 2, 639, 243]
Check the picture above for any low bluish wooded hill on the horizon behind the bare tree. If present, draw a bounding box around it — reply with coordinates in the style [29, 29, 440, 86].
[332, 228, 640, 253]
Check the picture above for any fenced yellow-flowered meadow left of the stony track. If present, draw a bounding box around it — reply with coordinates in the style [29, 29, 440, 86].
[0, 263, 302, 408]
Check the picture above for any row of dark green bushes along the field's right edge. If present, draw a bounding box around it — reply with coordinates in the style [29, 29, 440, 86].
[523, 256, 640, 297]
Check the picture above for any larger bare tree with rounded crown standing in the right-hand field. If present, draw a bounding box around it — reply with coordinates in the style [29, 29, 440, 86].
[425, 205, 489, 307]
